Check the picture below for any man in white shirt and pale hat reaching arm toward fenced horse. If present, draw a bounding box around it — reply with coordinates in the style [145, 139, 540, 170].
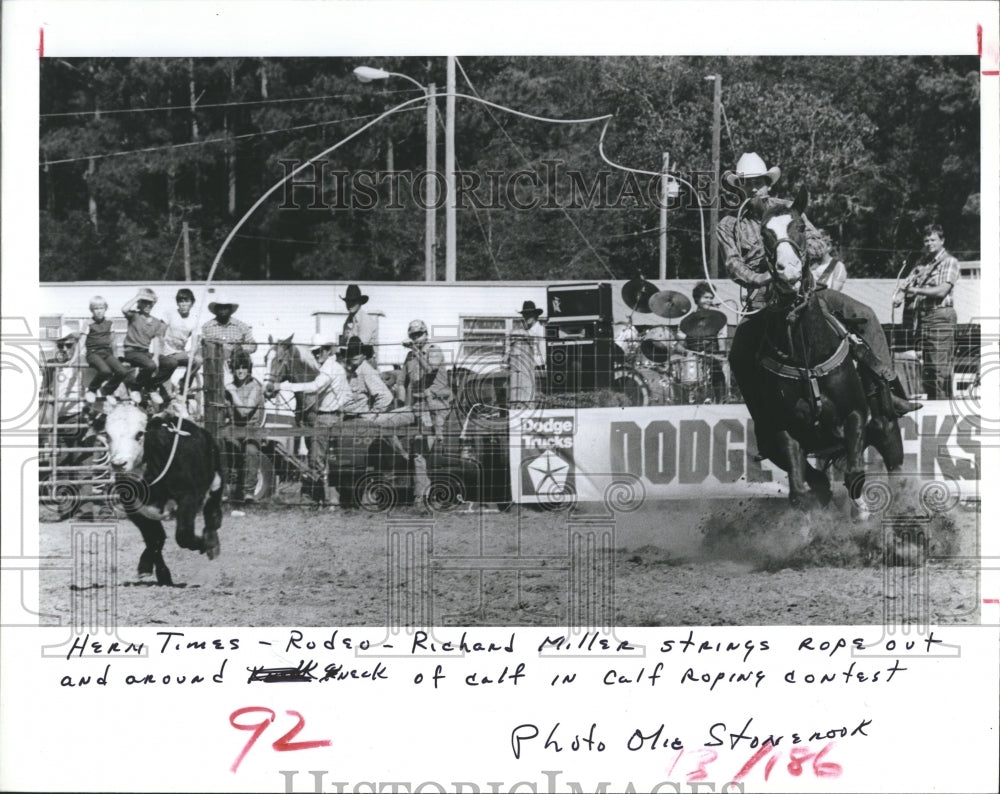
[281, 333, 352, 505]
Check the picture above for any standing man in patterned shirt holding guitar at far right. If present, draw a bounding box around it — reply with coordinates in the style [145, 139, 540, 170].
[892, 224, 959, 400]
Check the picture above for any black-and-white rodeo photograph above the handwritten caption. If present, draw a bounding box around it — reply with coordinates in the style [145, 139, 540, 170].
[31, 56, 982, 625]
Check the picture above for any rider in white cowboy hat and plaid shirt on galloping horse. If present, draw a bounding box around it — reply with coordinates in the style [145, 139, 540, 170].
[716, 152, 919, 459]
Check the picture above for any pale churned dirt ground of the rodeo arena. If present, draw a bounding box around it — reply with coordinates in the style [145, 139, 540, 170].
[40, 476, 979, 626]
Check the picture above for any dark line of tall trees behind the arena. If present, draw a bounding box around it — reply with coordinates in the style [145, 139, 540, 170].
[39, 57, 980, 281]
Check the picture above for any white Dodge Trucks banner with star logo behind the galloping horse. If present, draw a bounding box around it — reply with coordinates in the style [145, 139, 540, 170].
[510, 401, 980, 506]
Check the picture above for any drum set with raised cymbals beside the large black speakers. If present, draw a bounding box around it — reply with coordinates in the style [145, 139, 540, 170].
[616, 277, 726, 405]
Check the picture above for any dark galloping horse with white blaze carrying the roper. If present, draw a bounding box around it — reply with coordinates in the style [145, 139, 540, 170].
[755, 190, 903, 517]
